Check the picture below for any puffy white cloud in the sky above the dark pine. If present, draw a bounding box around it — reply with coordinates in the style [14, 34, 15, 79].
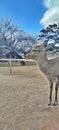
[40, 0, 59, 26]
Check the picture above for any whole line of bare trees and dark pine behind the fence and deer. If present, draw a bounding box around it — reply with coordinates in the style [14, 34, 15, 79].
[0, 18, 59, 58]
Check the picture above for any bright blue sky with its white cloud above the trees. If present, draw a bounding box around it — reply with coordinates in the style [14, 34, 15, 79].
[0, 0, 59, 34]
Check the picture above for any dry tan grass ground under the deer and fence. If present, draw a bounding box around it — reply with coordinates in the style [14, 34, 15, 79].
[0, 65, 59, 130]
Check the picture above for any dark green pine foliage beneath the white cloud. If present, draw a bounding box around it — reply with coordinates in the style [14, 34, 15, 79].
[39, 23, 59, 43]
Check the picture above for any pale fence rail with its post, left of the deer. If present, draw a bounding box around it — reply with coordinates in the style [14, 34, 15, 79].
[0, 59, 36, 75]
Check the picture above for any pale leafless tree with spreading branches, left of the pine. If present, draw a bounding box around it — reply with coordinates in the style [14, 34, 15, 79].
[0, 18, 37, 57]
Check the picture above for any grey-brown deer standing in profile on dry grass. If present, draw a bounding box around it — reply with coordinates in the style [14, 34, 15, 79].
[26, 45, 59, 106]
